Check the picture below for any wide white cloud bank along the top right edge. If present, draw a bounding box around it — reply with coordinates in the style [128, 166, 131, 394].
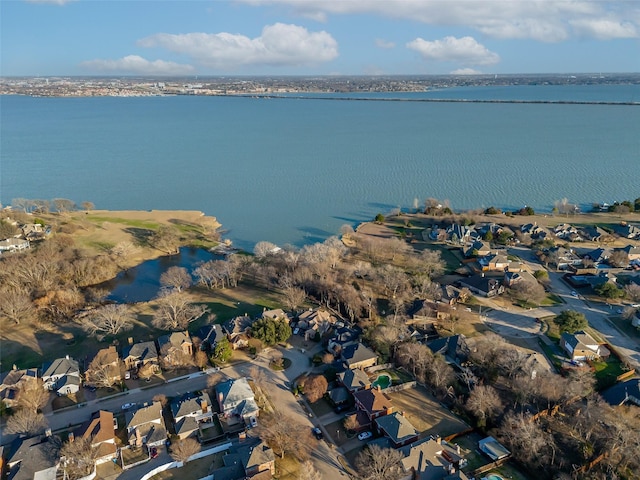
[236, 0, 640, 42]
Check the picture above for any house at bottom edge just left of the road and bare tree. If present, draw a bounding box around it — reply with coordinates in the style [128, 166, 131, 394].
[209, 438, 276, 480]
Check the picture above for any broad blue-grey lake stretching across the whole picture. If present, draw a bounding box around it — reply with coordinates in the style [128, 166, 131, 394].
[0, 85, 640, 249]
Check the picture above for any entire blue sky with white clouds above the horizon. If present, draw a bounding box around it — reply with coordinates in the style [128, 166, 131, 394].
[0, 0, 640, 76]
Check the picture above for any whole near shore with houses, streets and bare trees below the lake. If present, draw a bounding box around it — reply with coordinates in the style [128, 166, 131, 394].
[0, 199, 640, 479]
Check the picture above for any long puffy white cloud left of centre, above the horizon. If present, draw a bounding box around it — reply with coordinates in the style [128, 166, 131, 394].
[138, 23, 338, 69]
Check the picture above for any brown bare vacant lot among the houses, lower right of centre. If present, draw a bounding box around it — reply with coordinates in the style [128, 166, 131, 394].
[388, 386, 469, 437]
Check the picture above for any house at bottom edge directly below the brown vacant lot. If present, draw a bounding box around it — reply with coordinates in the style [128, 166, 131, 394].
[399, 437, 468, 480]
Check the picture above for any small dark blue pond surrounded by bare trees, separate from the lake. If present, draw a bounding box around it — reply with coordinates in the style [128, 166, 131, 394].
[98, 247, 224, 303]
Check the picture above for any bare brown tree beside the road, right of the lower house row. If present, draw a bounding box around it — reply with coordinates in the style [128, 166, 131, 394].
[258, 410, 312, 460]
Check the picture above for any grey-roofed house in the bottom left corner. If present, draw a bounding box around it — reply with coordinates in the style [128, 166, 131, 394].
[7, 436, 60, 480]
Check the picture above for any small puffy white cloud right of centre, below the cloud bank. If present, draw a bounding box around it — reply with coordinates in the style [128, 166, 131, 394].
[407, 37, 500, 65]
